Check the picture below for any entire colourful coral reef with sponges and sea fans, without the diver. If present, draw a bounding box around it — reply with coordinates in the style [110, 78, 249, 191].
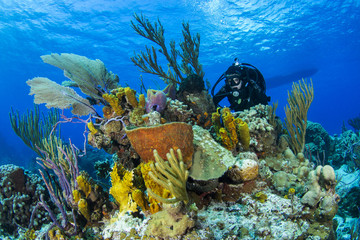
[7, 14, 348, 240]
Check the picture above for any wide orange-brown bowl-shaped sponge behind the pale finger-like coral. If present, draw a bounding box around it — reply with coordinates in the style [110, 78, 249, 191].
[126, 122, 194, 168]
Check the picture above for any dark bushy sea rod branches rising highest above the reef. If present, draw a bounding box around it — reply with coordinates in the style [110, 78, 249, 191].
[131, 14, 204, 85]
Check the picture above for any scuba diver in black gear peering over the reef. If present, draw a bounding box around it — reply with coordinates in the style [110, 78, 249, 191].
[211, 58, 270, 111]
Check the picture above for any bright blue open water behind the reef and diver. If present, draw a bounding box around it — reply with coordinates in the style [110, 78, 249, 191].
[0, 0, 360, 164]
